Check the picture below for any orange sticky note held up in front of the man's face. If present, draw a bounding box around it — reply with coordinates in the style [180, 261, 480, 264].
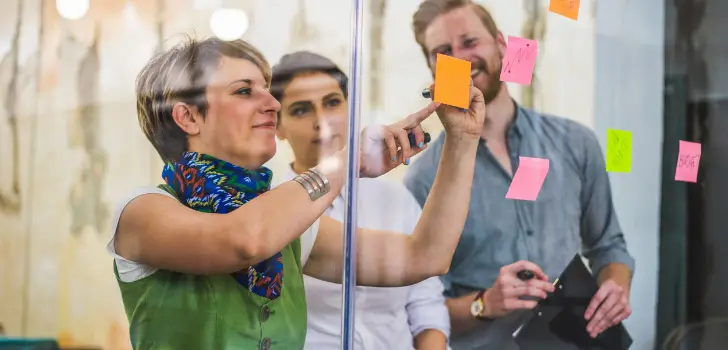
[433, 54, 470, 108]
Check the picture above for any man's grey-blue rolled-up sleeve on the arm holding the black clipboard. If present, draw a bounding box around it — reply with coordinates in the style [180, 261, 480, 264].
[581, 130, 635, 276]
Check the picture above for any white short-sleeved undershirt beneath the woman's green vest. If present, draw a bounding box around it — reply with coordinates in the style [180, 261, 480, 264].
[106, 186, 319, 283]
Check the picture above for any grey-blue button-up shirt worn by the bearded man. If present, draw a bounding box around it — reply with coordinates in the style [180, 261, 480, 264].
[404, 105, 634, 349]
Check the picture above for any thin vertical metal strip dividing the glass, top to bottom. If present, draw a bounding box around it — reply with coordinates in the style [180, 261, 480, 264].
[341, 0, 364, 350]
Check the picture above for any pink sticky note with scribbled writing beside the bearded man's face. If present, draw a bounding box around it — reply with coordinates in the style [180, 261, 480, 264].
[501, 35, 538, 85]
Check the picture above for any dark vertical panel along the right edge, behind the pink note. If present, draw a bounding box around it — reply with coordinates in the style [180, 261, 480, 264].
[658, 1, 728, 349]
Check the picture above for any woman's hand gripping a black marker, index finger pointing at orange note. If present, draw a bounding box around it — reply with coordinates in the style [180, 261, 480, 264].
[359, 101, 438, 177]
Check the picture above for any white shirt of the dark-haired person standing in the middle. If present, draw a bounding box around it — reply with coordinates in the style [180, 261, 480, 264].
[277, 168, 450, 350]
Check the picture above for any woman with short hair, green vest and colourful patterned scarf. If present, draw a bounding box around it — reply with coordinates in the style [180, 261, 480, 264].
[108, 38, 485, 350]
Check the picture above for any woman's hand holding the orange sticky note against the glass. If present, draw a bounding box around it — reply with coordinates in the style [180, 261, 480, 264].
[430, 80, 485, 138]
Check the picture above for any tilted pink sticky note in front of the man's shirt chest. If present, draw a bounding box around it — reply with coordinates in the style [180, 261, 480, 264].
[506, 157, 549, 201]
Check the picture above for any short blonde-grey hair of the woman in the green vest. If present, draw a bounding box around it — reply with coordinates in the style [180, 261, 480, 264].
[136, 36, 271, 162]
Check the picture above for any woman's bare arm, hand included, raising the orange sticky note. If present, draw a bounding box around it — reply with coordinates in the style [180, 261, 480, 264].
[304, 85, 485, 286]
